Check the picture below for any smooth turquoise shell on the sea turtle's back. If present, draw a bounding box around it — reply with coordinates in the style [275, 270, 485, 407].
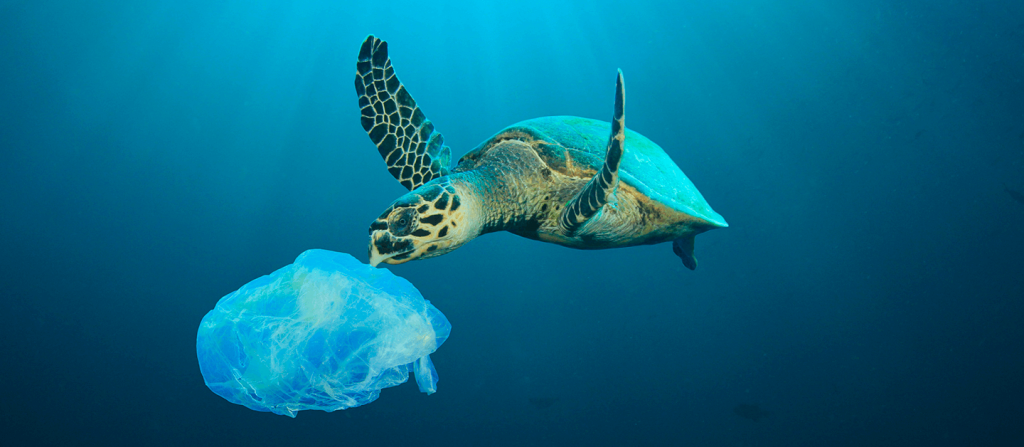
[457, 117, 728, 227]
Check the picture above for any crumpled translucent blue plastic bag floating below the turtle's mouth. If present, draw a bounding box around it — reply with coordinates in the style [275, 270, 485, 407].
[196, 250, 452, 417]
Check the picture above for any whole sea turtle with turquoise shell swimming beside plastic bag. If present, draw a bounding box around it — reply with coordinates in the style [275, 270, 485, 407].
[355, 36, 727, 269]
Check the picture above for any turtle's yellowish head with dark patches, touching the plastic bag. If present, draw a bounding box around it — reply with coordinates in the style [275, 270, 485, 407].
[370, 181, 481, 267]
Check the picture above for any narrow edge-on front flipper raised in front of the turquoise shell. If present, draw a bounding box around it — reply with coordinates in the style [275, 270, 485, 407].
[558, 70, 626, 234]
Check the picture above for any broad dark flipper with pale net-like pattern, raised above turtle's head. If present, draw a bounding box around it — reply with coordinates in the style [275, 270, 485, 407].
[355, 36, 452, 190]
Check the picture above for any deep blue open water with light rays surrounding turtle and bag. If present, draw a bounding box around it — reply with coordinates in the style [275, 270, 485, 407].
[0, 0, 1024, 446]
